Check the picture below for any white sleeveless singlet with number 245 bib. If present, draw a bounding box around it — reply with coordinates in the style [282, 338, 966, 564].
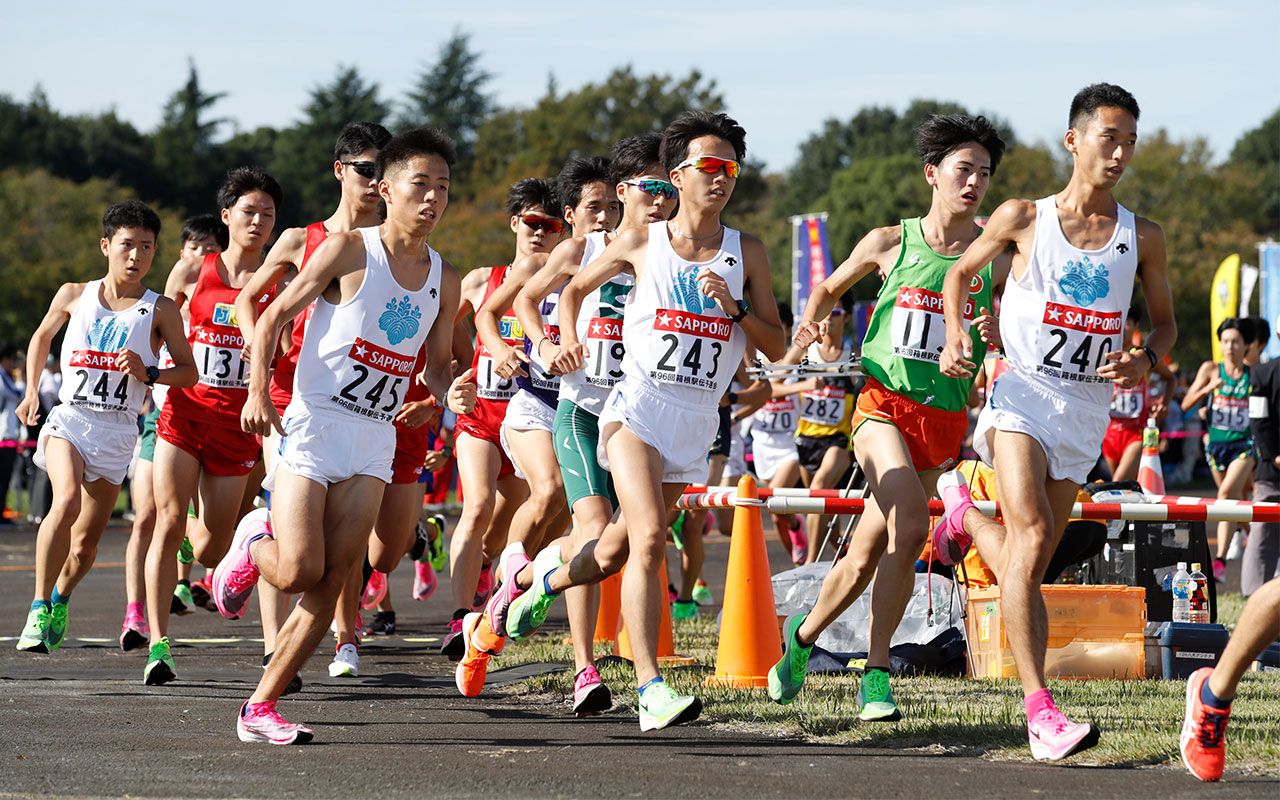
[293, 227, 442, 424]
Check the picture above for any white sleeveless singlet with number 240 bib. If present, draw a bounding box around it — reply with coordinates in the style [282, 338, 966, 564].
[1000, 196, 1138, 412]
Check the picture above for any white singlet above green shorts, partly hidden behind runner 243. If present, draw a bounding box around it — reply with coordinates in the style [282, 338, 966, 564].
[561, 232, 636, 416]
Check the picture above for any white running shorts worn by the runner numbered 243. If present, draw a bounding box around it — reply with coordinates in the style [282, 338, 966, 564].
[595, 378, 719, 484]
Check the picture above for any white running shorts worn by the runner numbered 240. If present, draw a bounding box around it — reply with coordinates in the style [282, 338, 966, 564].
[973, 370, 1111, 484]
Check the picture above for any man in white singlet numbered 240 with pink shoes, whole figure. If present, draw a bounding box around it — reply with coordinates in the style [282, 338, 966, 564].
[934, 83, 1178, 760]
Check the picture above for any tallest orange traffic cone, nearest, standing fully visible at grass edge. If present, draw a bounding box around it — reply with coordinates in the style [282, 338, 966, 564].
[707, 475, 782, 687]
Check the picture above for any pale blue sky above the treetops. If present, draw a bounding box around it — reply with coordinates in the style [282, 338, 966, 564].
[0, 0, 1280, 169]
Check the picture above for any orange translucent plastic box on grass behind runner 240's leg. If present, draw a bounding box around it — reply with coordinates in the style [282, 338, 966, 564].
[965, 585, 1147, 678]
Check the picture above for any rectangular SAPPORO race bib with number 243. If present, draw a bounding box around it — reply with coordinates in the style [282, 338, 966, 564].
[645, 308, 735, 392]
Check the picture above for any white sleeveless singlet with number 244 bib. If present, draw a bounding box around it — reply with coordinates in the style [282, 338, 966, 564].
[58, 280, 160, 426]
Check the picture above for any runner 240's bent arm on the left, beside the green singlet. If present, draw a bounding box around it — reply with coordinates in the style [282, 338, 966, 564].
[938, 200, 1036, 378]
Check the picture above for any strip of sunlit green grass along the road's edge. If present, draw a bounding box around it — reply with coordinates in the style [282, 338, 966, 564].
[494, 609, 1280, 773]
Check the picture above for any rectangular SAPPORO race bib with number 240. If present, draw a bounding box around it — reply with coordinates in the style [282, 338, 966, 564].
[1036, 301, 1124, 383]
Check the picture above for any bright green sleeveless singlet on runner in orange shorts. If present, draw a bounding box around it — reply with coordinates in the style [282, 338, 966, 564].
[863, 218, 991, 411]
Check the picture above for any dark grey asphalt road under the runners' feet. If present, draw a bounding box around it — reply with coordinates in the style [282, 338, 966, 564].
[0, 529, 1280, 800]
